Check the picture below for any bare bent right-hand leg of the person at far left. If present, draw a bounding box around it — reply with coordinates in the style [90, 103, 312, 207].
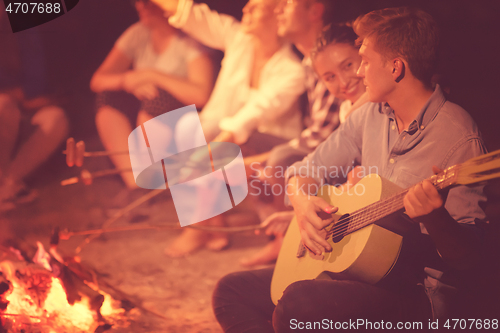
[8, 106, 69, 181]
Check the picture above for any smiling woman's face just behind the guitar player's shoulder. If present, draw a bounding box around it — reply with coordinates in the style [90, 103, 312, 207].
[313, 43, 366, 103]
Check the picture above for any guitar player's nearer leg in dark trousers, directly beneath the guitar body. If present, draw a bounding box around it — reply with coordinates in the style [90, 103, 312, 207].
[273, 280, 432, 333]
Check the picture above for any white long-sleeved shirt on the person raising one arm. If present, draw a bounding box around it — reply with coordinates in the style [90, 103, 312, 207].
[169, 0, 305, 144]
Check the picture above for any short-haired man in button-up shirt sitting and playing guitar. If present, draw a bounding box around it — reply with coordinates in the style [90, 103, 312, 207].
[213, 8, 485, 332]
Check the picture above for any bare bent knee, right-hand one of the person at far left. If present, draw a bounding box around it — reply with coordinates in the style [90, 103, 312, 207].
[31, 106, 69, 137]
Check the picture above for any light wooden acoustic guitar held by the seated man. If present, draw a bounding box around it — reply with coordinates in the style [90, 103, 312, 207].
[271, 150, 500, 304]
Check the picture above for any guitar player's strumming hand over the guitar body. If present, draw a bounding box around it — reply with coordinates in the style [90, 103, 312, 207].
[292, 195, 338, 255]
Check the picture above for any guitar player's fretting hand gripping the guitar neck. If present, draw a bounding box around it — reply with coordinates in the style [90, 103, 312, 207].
[403, 166, 444, 219]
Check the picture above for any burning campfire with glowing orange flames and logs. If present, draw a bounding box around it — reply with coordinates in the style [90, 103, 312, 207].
[0, 243, 127, 333]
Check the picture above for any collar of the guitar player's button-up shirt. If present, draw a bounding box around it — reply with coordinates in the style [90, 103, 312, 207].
[379, 84, 446, 132]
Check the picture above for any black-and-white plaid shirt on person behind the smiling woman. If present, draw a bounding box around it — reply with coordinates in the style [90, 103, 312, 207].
[298, 58, 340, 151]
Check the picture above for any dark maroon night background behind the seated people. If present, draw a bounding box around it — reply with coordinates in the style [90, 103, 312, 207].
[0, 0, 500, 169]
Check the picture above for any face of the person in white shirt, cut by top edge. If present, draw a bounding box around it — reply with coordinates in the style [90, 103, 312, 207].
[241, 0, 278, 36]
